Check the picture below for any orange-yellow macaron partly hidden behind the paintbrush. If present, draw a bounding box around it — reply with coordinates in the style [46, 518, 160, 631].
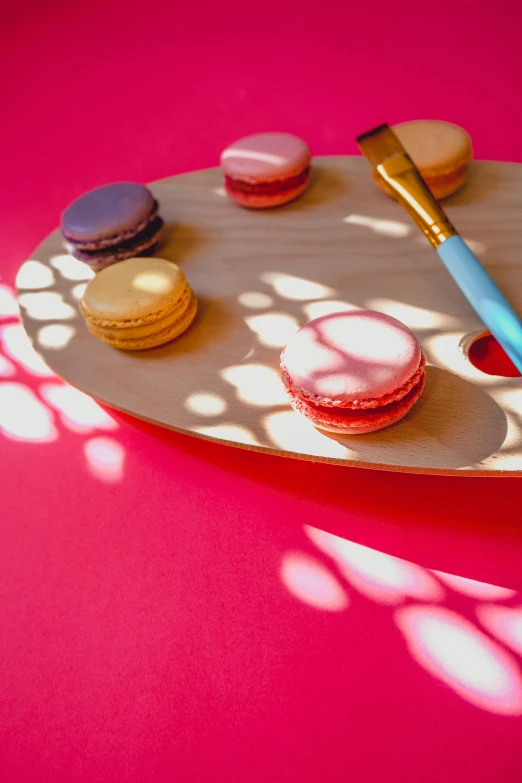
[374, 120, 473, 201]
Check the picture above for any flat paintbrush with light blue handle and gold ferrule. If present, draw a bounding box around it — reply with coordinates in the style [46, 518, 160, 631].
[356, 125, 522, 372]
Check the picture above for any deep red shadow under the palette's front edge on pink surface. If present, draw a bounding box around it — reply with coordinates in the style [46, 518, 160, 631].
[118, 404, 522, 597]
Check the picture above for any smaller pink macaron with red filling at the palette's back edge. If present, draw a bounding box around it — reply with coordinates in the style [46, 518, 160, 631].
[221, 133, 311, 209]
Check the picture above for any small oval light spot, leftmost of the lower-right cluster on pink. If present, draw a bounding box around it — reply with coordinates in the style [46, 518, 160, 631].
[281, 552, 349, 612]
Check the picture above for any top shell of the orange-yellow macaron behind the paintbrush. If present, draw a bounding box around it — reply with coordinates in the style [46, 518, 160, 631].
[393, 120, 473, 177]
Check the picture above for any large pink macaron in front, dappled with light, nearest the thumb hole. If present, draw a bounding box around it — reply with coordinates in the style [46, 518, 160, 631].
[281, 310, 425, 435]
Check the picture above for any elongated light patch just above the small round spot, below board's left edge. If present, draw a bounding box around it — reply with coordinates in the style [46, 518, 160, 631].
[40, 383, 118, 433]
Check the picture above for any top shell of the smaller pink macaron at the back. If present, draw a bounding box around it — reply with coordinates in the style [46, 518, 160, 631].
[221, 133, 310, 182]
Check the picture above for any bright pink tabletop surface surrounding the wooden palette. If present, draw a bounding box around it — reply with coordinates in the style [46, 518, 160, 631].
[0, 0, 522, 783]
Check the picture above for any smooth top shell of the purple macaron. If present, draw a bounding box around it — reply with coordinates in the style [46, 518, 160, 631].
[62, 182, 156, 241]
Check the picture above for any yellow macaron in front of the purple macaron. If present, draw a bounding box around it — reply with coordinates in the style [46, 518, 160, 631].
[80, 257, 197, 351]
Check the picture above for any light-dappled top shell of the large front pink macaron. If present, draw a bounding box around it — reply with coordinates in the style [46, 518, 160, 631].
[281, 310, 423, 407]
